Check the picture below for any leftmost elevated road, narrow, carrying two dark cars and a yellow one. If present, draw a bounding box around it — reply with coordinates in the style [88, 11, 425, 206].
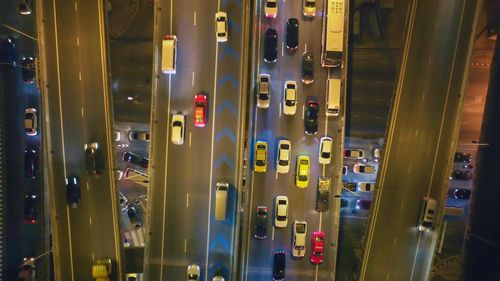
[38, 0, 122, 280]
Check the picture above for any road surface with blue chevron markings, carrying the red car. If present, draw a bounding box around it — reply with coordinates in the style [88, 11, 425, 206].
[144, 0, 244, 280]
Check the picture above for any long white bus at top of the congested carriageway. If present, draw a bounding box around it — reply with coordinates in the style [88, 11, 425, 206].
[321, 0, 344, 67]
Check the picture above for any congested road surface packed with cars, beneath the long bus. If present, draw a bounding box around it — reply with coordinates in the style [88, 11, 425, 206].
[246, 1, 342, 280]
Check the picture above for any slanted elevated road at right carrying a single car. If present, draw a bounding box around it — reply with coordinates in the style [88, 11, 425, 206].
[359, 0, 476, 281]
